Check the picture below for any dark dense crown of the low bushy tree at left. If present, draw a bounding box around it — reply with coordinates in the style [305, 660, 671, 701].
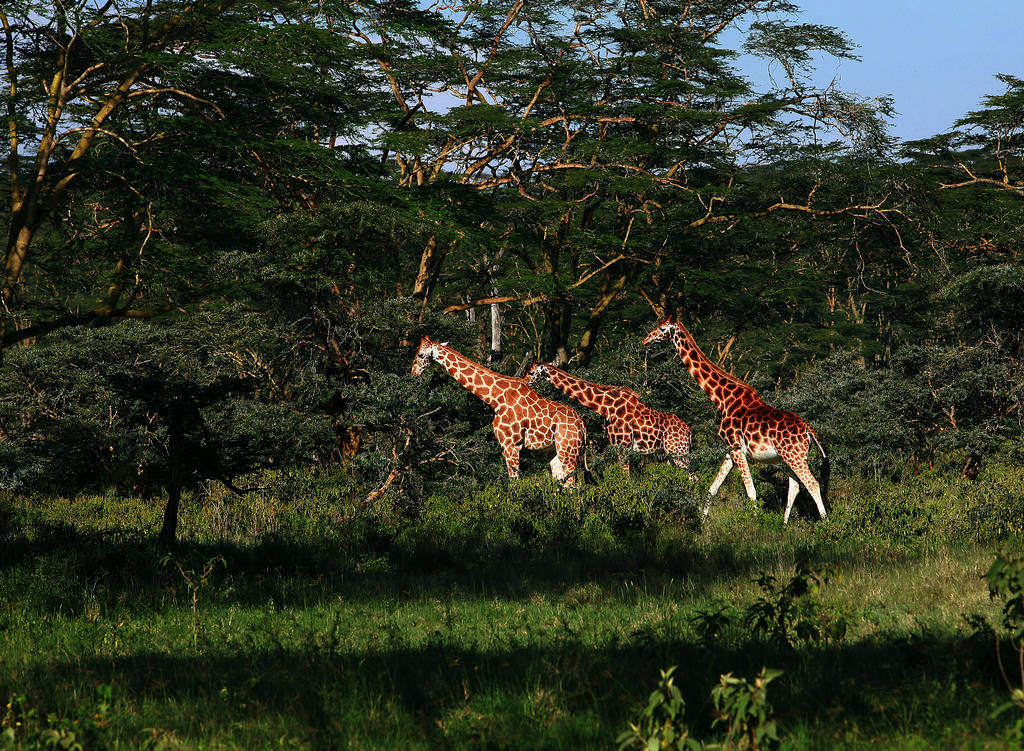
[0, 309, 329, 493]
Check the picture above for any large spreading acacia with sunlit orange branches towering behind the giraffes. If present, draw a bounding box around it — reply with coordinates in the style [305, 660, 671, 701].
[340, 0, 896, 359]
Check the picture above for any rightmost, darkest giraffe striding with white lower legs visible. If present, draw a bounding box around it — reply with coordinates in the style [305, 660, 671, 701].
[643, 317, 828, 524]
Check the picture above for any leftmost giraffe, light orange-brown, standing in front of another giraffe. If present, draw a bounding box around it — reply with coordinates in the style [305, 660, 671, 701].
[413, 336, 587, 488]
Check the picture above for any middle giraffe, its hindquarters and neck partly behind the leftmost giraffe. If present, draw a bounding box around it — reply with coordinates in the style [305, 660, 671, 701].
[526, 363, 693, 477]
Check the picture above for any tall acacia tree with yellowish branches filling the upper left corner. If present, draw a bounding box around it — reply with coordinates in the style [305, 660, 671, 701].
[0, 0, 391, 346]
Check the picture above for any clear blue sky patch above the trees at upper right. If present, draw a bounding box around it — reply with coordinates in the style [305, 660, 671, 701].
[774, 0, 1024, 140]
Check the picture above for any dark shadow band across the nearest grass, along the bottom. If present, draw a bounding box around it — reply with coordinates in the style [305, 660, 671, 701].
[8, 632, 1007, 748]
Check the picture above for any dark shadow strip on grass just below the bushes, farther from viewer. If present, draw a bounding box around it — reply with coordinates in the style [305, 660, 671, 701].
[0, 516, 929, 615]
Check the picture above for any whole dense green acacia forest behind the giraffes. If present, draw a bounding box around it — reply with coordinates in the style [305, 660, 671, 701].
[0, 0, 1024, 539]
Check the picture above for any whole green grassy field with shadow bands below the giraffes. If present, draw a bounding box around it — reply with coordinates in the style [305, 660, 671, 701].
[0, 467, 1024, 749]
